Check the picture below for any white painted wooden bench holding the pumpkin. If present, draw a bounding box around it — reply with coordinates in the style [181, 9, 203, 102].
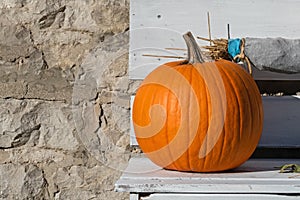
[115, 0, 300, 200]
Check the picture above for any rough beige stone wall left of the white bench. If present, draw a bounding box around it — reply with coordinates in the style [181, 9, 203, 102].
[0, 0, 133, 200]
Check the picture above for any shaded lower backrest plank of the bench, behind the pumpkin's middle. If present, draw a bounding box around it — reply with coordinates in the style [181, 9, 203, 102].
[130, 95, 300, 147]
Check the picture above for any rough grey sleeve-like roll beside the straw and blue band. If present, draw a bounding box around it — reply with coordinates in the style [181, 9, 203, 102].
[245, 38, 300, 73]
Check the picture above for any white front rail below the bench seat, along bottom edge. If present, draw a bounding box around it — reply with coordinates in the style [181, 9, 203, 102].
[141, 194, 300, 200]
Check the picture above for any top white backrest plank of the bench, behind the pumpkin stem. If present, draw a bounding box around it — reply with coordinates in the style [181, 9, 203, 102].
[129, 0, 300, 79]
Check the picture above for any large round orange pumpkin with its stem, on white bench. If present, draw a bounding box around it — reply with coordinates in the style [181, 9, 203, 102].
[132, 32, 263, 172]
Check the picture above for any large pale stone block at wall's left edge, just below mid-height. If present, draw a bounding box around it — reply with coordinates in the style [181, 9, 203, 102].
[0, 99, 79, 150]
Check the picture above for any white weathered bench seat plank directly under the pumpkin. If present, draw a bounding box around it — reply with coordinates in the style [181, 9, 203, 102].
[115, 158, 300, 194]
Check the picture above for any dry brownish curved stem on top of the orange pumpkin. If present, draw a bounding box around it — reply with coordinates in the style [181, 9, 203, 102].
[183, 31, 204, 64]
